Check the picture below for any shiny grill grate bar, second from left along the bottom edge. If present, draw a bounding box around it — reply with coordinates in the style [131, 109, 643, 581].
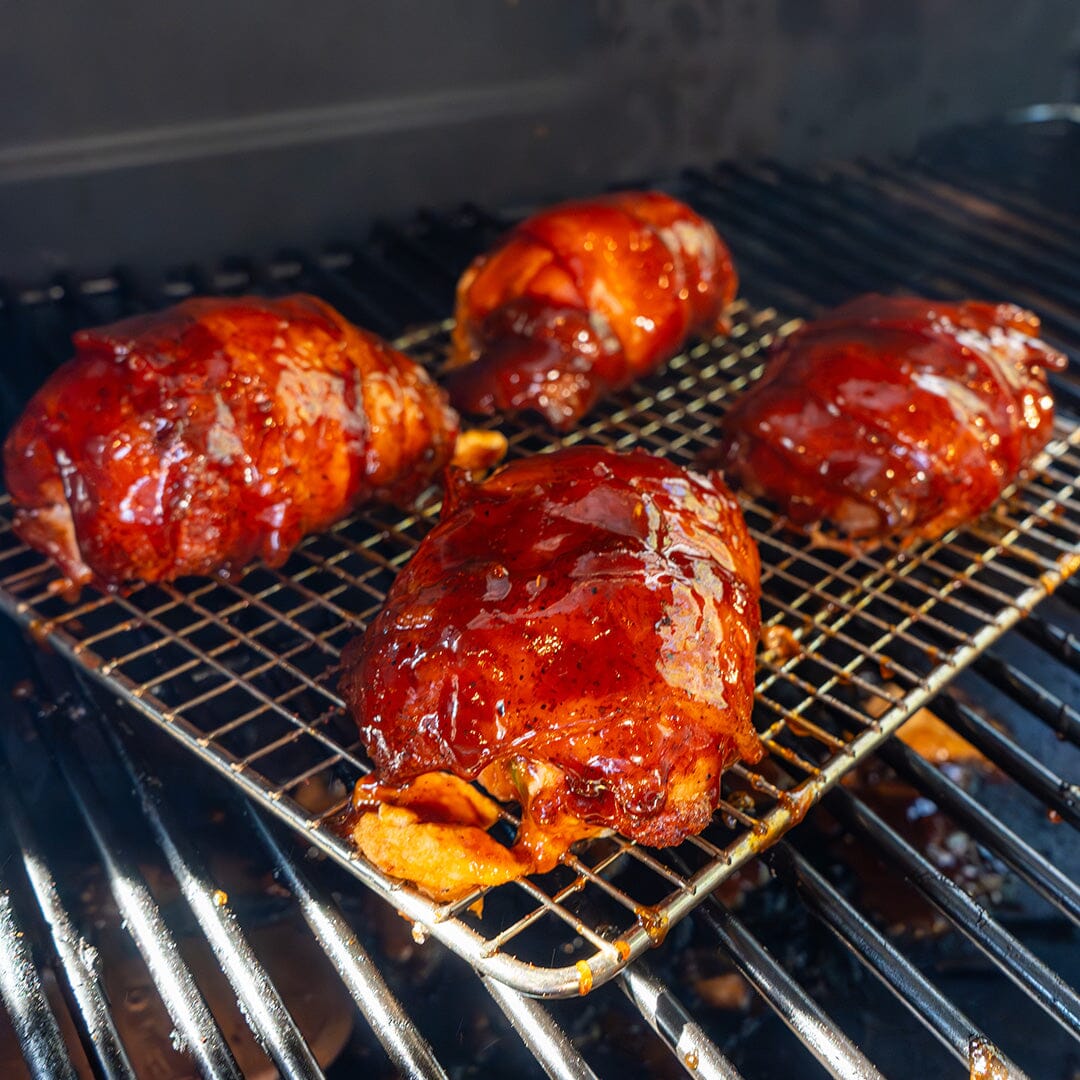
[0, 762, 135, 1080]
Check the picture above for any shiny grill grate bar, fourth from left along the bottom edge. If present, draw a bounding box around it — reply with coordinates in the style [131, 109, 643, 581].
[98, 719, 323, 1078]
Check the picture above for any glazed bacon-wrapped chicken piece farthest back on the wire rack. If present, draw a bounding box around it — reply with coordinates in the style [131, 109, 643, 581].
[449, 191, 737, 430]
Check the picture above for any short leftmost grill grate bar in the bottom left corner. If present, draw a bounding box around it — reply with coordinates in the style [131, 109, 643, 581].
[0, 888, 77, 1080]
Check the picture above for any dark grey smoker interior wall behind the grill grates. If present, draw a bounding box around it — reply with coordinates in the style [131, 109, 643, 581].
[0, 0, 1080, 281]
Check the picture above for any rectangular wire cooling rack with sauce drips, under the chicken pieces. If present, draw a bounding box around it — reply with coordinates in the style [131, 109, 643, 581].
[0, 305, 1080, 997]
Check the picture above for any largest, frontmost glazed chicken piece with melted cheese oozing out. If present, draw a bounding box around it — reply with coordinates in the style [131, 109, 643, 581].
[340, 447, 761, 894]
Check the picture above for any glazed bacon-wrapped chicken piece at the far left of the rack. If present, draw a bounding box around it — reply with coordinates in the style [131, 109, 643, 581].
[4, 296, 458, 586]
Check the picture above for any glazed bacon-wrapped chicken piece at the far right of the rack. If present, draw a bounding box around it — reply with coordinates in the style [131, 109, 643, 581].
[706, 296, 1065, 538]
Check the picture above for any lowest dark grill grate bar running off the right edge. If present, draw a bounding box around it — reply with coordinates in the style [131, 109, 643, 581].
[828, 787, 1080, 1038]
